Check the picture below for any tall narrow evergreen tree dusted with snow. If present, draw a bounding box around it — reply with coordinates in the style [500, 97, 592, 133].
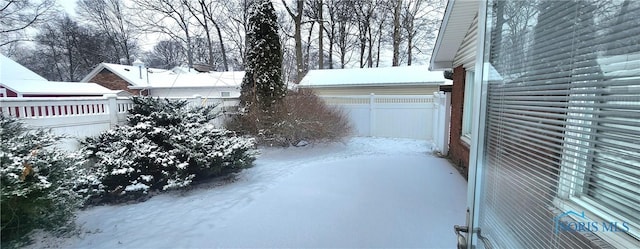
[240, 0, 286, 115]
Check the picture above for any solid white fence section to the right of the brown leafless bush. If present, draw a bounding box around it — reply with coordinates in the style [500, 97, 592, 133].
[321, 94, 436, 140]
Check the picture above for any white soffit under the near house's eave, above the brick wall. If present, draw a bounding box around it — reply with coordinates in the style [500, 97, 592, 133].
[429, 0, 480, 70]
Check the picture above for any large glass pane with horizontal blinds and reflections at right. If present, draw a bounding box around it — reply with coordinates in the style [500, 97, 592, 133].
[478, 0, 640, 248]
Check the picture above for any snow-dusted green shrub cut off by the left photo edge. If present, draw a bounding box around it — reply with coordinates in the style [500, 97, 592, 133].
[0, 115, 93, 245]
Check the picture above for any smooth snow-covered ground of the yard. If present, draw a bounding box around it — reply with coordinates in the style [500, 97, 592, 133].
[28, 138, 466, 248]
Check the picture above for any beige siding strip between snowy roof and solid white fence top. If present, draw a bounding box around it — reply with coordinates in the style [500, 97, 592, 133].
[313, 85, 438, 96]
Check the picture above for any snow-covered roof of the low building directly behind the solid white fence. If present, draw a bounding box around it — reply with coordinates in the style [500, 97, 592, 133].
[300, 66, 445, 87]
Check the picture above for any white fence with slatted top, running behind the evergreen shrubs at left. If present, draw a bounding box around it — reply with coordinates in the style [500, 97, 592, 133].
[0, 94, 239, 150]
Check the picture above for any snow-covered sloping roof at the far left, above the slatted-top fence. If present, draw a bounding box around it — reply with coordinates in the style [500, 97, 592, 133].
[0, 54, 117, 95]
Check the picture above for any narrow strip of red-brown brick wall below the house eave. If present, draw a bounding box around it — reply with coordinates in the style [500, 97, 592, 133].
[449, 66, 469, 178]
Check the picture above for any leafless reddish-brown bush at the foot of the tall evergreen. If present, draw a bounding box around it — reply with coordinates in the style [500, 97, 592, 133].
[227, 92, 351, 146]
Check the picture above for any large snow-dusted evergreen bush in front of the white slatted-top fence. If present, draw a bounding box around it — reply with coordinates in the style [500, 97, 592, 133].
[83, 97, 255, 202]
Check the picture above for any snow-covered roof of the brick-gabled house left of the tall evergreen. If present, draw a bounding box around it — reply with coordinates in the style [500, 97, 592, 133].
[82, 63, 244, 89]
